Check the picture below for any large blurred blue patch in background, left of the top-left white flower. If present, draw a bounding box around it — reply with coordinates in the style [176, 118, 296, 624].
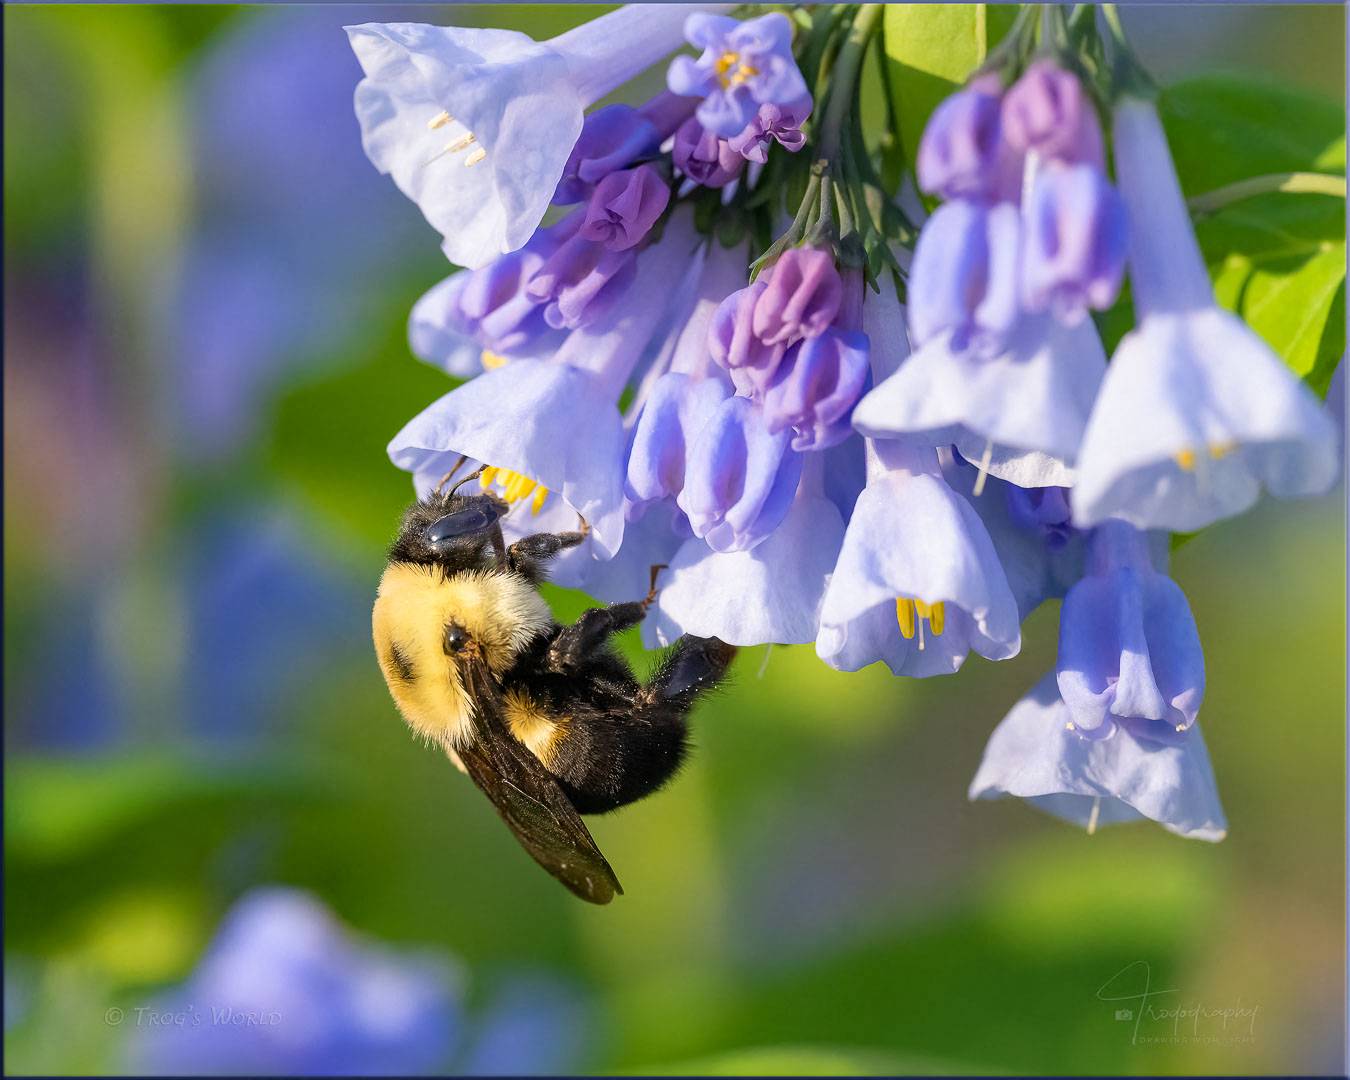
[166, 7, 433, 460]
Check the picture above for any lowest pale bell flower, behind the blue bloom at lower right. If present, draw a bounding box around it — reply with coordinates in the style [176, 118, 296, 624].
[969, 671, 1229, 841]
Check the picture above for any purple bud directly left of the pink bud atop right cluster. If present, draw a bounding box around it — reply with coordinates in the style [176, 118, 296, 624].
[915, 78, 1021, 198]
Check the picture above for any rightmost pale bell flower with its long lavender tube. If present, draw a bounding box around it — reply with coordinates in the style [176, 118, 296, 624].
[1073, 99, 1341, 532]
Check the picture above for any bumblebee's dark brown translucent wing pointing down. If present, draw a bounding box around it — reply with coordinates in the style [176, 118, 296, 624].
[458, 656, 624, 903]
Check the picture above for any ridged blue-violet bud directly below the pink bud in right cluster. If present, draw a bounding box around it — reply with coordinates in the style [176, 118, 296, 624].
[1022, 163, 1130, 325]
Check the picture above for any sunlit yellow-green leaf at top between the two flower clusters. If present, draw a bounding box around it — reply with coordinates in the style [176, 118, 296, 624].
[883, 4, 1018, 178]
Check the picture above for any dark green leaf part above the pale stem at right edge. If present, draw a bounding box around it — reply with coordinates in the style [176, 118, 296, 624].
[1158, 76, 1346, 197]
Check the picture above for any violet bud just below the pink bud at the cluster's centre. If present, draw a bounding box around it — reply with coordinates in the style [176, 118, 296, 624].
[764, 328, 869, 451]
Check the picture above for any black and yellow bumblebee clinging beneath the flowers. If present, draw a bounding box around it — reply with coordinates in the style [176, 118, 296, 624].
[373, 470, 736, 903]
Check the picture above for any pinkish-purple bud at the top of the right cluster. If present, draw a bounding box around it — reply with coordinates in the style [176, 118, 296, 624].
[1002, 59, 1106, 170]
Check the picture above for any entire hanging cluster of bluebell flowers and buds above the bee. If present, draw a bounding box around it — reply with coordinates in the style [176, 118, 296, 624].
[348, 4, 1339, 840]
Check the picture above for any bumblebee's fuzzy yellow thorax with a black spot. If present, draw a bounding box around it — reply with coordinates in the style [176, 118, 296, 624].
[373, 563, 554, 748]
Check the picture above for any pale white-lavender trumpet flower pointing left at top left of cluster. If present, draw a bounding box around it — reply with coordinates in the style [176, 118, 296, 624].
[347, 4, 702, 267]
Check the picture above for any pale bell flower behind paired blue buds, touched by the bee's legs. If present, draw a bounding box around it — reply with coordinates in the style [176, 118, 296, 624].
[643, 450, 844, 645]
